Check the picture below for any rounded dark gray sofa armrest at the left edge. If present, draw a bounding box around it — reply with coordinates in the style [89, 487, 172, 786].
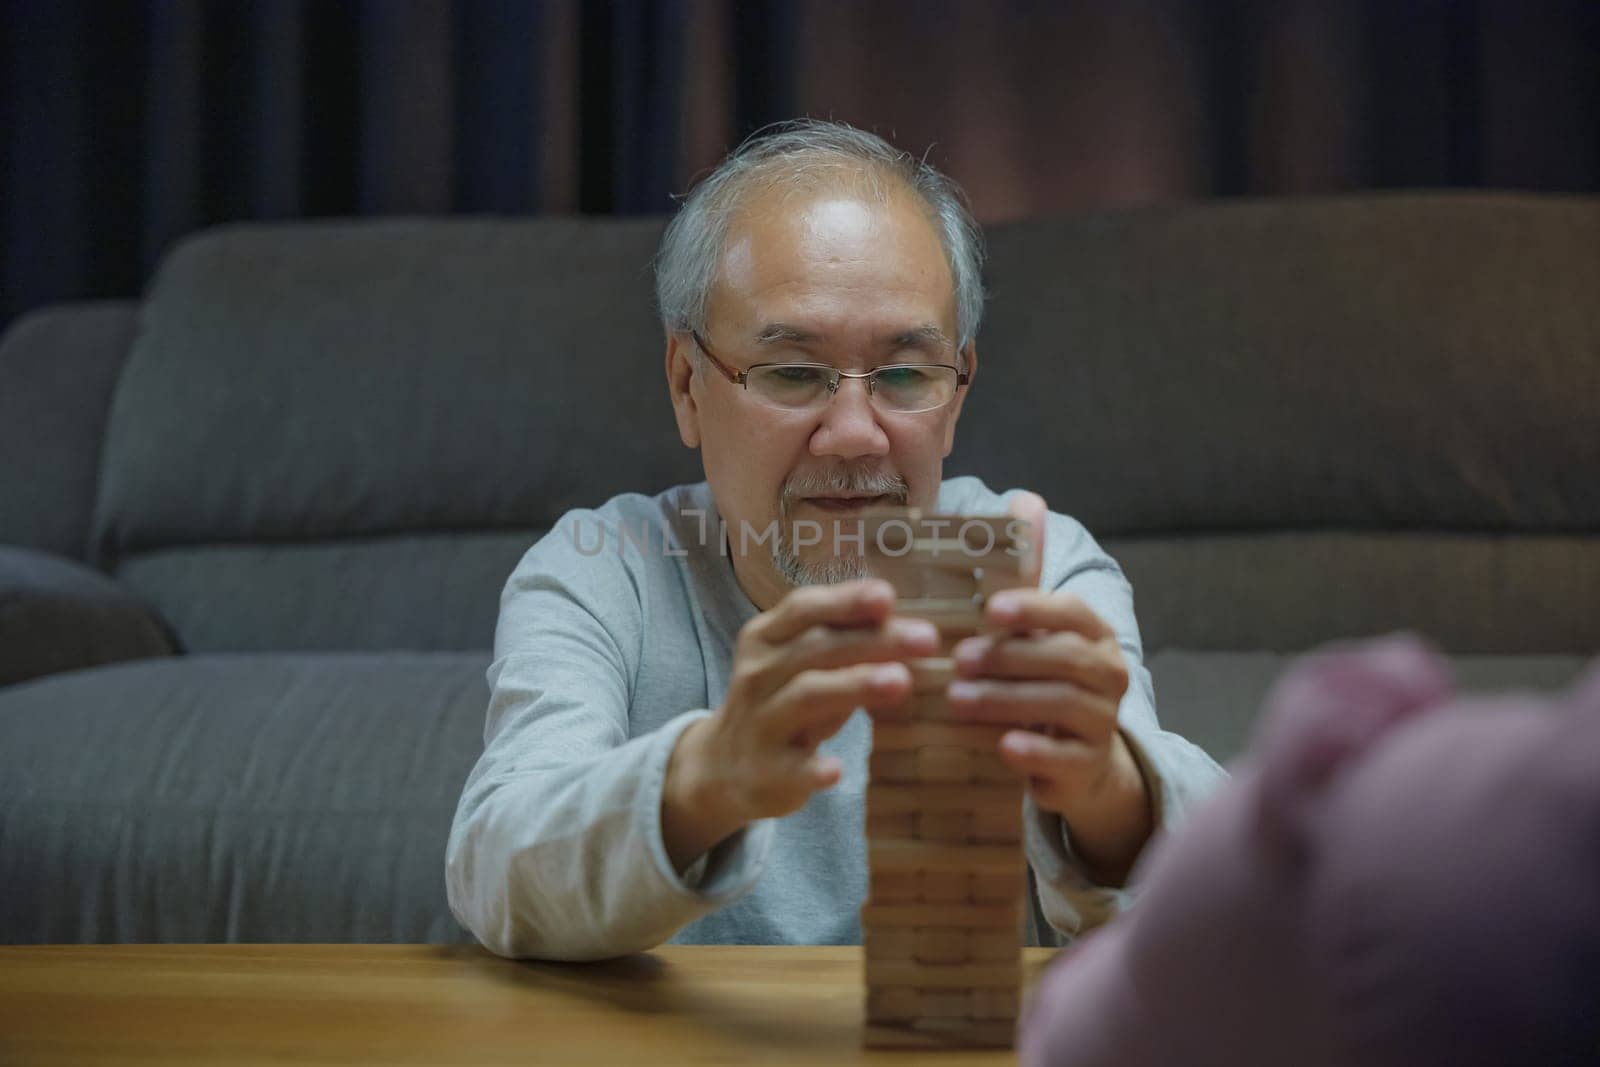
[0, 544, 178, 686]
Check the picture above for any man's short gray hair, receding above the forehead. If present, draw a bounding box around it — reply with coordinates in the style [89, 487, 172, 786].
[656, 118, 984, 346]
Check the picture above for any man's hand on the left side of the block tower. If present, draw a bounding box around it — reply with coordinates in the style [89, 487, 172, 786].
[661, 579, 939, 872]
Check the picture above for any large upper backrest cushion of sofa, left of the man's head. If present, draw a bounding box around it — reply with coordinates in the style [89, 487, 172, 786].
[96, 219, 699, 561]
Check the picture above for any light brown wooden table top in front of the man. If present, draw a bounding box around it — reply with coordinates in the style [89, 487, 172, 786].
[0, 945, 1051, 1067]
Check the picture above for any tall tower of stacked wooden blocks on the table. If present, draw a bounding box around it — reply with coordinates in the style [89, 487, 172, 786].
[861, 510, 1027, 1048]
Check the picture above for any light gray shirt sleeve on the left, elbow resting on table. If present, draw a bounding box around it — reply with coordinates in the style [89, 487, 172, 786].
[445, 514, 773, 960]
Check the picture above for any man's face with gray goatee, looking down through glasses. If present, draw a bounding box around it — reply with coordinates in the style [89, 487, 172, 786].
[667, 183, 974, 608]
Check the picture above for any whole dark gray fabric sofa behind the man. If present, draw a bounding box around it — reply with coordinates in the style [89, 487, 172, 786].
[0, 195, 1600, 942]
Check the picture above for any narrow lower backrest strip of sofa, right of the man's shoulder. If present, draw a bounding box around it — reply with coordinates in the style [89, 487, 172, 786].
[1106, 530, 1600, 654]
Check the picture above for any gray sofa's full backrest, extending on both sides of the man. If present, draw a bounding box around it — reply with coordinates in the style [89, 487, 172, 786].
[94, 195, 1600, 651]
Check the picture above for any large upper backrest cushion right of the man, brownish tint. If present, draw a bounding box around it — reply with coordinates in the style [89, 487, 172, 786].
[952, 194, 1600, 536]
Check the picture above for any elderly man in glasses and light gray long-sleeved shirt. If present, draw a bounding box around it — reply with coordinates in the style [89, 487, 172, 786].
[446, 122, 1221, 960]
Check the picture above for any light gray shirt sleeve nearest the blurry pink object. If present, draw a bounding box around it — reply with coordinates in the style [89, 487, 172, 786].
[1024, 515, 1227, 937]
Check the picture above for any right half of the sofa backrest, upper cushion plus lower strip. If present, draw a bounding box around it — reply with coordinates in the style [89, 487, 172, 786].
[960, 194, 1600, 654]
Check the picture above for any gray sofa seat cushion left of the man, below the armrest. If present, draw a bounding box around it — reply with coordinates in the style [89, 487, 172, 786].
[0, 653, 488, 942]
